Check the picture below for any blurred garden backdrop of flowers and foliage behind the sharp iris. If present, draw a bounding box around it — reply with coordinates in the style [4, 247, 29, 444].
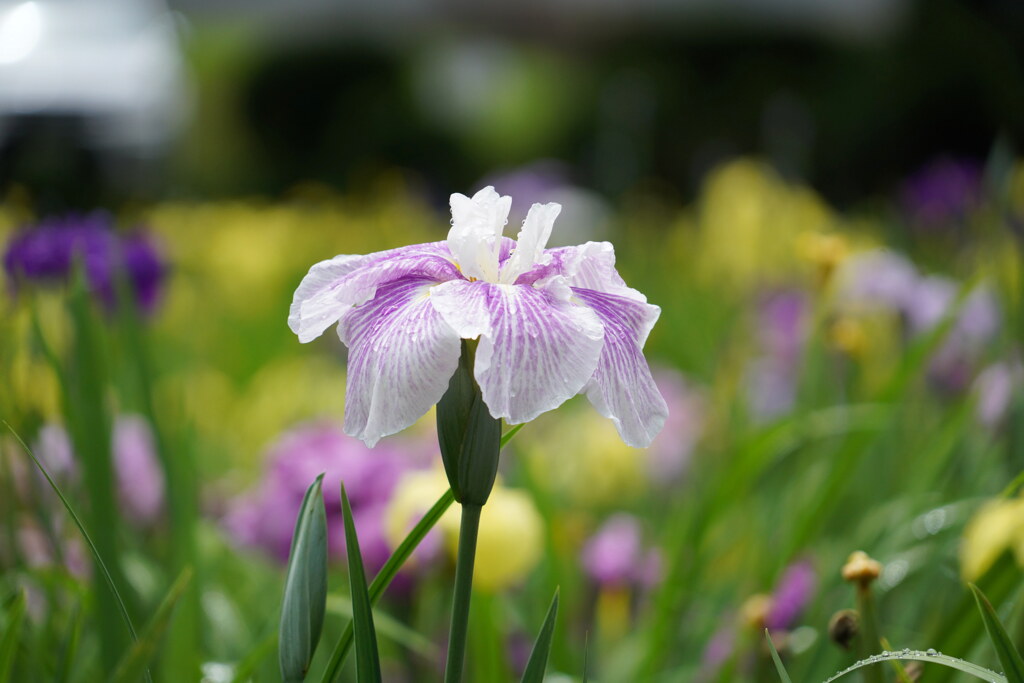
[0, 0, 1024, 681]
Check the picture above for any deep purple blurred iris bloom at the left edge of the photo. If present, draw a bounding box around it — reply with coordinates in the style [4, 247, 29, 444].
[4, 212, 166, 310]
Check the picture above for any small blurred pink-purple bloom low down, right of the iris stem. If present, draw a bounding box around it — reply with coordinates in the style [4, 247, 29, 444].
[580, 513, 662, 588]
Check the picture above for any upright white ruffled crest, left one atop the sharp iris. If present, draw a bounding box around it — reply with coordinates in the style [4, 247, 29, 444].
[447, 186, 512, 283]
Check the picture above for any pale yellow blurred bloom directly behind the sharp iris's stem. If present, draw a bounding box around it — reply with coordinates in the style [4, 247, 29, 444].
[384, 467, 544, 592]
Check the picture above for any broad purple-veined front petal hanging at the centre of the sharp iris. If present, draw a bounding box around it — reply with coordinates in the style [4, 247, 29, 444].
[430, 281, 604, 424]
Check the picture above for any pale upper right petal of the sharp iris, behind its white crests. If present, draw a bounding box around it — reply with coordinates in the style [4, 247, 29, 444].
[516, 242, 647, 301]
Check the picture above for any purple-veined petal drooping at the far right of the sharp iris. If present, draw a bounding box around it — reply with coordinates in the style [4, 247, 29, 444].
[572, 288, 669, 447]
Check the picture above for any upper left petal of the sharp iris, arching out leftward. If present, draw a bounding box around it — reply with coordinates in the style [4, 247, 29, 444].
[288, 242, 461, 343]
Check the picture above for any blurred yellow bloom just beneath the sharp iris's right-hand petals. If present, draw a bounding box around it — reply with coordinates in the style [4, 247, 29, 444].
[525, 411, 647, 506]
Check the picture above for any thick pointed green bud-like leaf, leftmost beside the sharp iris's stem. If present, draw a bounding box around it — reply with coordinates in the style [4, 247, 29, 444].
[278, 474, 327, 683]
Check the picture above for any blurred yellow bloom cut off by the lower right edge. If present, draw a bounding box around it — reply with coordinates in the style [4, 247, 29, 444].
[959, 498, 1024, 581]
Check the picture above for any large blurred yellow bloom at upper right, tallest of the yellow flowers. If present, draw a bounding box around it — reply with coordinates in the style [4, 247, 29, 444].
[697, 160, 838, 291]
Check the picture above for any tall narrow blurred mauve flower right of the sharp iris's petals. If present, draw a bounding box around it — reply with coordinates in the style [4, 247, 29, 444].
[748, 291, 807, 420]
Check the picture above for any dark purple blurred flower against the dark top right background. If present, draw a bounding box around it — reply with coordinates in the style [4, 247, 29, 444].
[902, 160, 982, 227]
